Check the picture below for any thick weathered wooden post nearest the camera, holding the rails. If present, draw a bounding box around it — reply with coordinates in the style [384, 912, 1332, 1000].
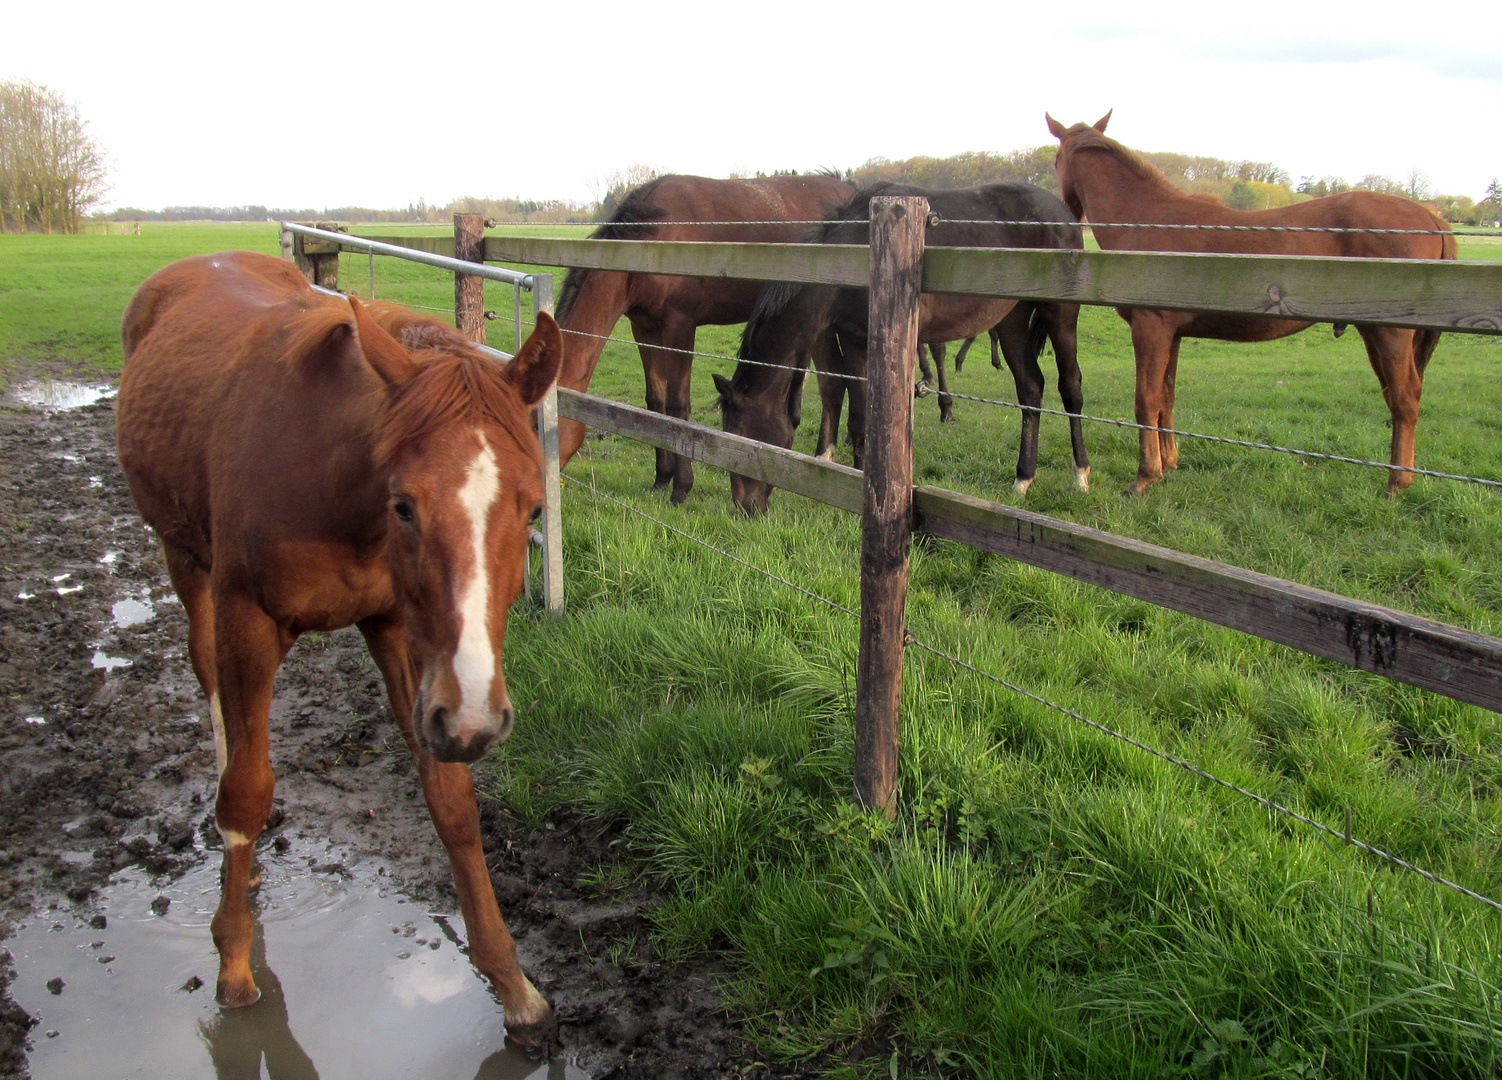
[855, 197, 928, 817]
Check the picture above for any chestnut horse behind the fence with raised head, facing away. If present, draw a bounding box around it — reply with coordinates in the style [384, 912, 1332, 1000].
[1044, 113, 1455, 497]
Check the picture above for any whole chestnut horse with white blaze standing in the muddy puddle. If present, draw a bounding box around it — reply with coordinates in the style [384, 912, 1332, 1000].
[117, 251, 563, 1039]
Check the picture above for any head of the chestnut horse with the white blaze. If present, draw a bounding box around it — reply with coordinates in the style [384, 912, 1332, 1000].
[350, 299, 563, 762]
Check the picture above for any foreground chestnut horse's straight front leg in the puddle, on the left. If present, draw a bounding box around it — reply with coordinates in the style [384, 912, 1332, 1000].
[212, 593, 293, 1008]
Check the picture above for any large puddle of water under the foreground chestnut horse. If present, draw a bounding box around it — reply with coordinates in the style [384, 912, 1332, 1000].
[6, 844, 587, 1080]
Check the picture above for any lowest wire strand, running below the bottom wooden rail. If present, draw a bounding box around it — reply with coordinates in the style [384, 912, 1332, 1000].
[563, 476, 1502, 912]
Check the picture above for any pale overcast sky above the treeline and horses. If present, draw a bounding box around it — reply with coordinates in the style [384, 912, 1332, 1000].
[11, 0, 1502, 209]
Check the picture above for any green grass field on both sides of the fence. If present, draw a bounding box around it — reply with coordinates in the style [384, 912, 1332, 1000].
[0, 225, 1502, 1080]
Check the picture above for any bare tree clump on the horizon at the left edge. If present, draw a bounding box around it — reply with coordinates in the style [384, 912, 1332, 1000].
[0, 80, 108, 233]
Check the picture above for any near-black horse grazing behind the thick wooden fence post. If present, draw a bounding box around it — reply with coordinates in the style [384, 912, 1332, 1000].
[715, 182, 1090, 514]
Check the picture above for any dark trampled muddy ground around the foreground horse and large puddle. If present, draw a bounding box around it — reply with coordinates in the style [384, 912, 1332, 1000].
[0, 383, 817, 1077]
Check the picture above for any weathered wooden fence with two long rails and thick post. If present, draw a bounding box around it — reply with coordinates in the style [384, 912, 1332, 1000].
[286, 214, 1502, 814]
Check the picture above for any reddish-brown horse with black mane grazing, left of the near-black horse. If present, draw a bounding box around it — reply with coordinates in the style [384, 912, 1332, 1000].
[557, 174, 855, 503]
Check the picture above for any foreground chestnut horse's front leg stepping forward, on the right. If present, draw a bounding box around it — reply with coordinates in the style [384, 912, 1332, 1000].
[360, 619, 553, 1044]
